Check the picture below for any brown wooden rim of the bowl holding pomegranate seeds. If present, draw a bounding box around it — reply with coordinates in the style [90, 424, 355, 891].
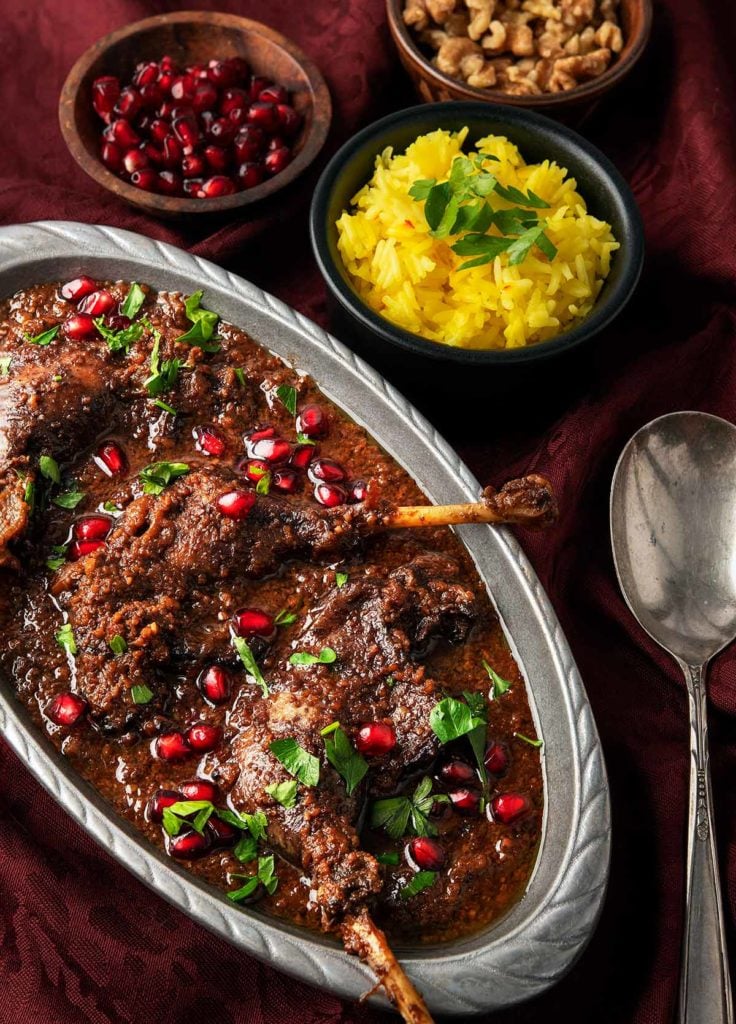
[58, 10, 332, 215]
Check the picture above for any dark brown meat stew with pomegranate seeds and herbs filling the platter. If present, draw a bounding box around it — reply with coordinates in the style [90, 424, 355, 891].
[0, 278, 543, 942]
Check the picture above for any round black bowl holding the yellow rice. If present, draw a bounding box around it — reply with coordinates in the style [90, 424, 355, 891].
[310, 102, 644, 368]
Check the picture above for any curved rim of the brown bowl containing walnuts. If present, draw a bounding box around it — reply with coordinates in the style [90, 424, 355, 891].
[386, 0, 653, 109]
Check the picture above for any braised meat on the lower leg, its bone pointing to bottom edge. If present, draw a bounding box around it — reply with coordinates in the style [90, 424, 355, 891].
[230, 555, 475, 927]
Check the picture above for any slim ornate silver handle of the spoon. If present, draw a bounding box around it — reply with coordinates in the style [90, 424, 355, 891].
[680, 666, 733, 1024]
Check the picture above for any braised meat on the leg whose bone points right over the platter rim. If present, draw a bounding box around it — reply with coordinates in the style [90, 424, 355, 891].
[52, 465, 378, 729]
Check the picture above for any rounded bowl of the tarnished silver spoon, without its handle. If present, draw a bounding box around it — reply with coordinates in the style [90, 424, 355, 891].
[611, 413, 736, 665]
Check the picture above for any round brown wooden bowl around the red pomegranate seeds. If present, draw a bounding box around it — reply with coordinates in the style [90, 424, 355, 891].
[58, 10, 332, 218]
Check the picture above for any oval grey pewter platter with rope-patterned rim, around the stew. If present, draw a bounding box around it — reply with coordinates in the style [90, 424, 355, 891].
[0, 221, 610, 1015]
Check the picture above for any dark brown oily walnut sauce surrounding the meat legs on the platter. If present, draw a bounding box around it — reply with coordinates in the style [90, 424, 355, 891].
[0, 283, 543, 943]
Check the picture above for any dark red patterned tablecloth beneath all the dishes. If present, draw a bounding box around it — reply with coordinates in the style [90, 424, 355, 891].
[0, 0, 736, 1024]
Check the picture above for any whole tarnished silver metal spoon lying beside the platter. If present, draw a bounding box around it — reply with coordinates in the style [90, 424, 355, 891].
[611, 413, 736, 1024]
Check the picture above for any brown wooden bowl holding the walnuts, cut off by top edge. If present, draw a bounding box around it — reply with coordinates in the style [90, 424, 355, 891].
[386, 0, 652, 117]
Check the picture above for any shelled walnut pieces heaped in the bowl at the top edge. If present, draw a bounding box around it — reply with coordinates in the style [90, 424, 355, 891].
[403, 0, 623, 95]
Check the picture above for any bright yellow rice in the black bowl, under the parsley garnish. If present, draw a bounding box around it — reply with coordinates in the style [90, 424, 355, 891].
[337, 128, 618, 348]
